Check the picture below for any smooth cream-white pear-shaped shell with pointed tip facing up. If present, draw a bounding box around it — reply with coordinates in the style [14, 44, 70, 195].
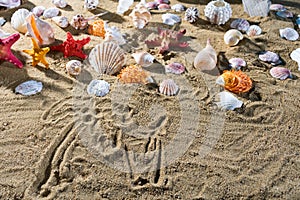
[194, 39, 217, 71]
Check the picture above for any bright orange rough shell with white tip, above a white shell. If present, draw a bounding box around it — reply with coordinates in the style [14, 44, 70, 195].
[216, 70, 252, 93]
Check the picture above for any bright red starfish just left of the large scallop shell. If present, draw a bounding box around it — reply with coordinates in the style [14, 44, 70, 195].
[50, 32, 91, 59]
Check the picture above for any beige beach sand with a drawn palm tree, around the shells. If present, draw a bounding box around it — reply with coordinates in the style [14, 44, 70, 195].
[0, 0, 300, 199]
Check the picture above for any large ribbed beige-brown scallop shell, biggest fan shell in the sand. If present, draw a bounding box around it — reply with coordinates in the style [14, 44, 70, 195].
[89, 42, 126, 75]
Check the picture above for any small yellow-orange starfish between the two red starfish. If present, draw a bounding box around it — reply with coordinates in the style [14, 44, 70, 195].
[23, 38, 50, 69]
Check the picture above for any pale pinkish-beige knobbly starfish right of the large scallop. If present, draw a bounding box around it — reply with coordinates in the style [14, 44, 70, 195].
[145, 28, 189, 53]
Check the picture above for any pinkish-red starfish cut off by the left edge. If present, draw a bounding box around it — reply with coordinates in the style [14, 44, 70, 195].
[0, 33, 23, 68]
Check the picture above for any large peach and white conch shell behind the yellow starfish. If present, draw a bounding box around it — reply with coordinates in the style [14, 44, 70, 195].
[26, 13, 55, 45]
